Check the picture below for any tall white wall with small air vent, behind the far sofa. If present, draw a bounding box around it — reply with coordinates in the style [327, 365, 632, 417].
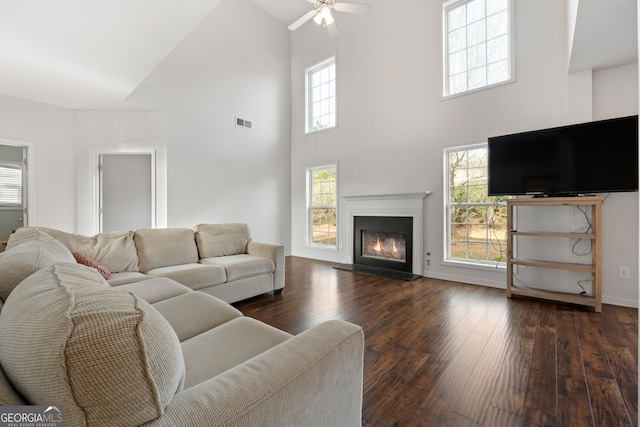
[128, 0, 291, 252]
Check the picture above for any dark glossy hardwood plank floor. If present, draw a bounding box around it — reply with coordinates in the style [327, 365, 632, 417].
[235, 257, 638, 427]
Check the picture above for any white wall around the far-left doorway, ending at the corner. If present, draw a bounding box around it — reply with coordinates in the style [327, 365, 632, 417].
[0, 96, 76, 230]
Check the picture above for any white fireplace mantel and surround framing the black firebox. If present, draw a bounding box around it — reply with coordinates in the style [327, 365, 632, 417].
[340, 191, 431, 275]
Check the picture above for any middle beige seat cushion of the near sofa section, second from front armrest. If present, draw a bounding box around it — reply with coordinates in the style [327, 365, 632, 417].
[153, 291, 242, 342]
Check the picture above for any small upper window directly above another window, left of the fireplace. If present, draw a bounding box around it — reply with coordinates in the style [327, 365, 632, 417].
[305, 56, 337, 133]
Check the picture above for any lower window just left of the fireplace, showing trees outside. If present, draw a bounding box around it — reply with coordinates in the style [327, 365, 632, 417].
[307, 165, 338, 249]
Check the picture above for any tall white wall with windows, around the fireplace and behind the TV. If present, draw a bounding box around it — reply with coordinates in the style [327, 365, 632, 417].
[291, 0, 638, 305]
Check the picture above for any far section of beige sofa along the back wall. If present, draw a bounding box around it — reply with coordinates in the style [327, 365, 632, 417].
[15, 224, 284, 303]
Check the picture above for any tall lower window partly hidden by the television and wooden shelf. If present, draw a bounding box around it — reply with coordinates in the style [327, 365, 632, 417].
[445, 144, 507, 266]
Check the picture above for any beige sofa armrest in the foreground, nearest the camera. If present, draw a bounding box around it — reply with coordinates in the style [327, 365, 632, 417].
[148, 320, 364, 427]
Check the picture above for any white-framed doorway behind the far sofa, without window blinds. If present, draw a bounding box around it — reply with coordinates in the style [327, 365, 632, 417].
[98, 152, 155, 233]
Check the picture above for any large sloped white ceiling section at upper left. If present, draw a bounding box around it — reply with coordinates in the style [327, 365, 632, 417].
[0, 0, 225, 109]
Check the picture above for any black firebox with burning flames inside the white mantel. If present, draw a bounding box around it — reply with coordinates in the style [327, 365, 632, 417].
[353, 216, 413, 273]
